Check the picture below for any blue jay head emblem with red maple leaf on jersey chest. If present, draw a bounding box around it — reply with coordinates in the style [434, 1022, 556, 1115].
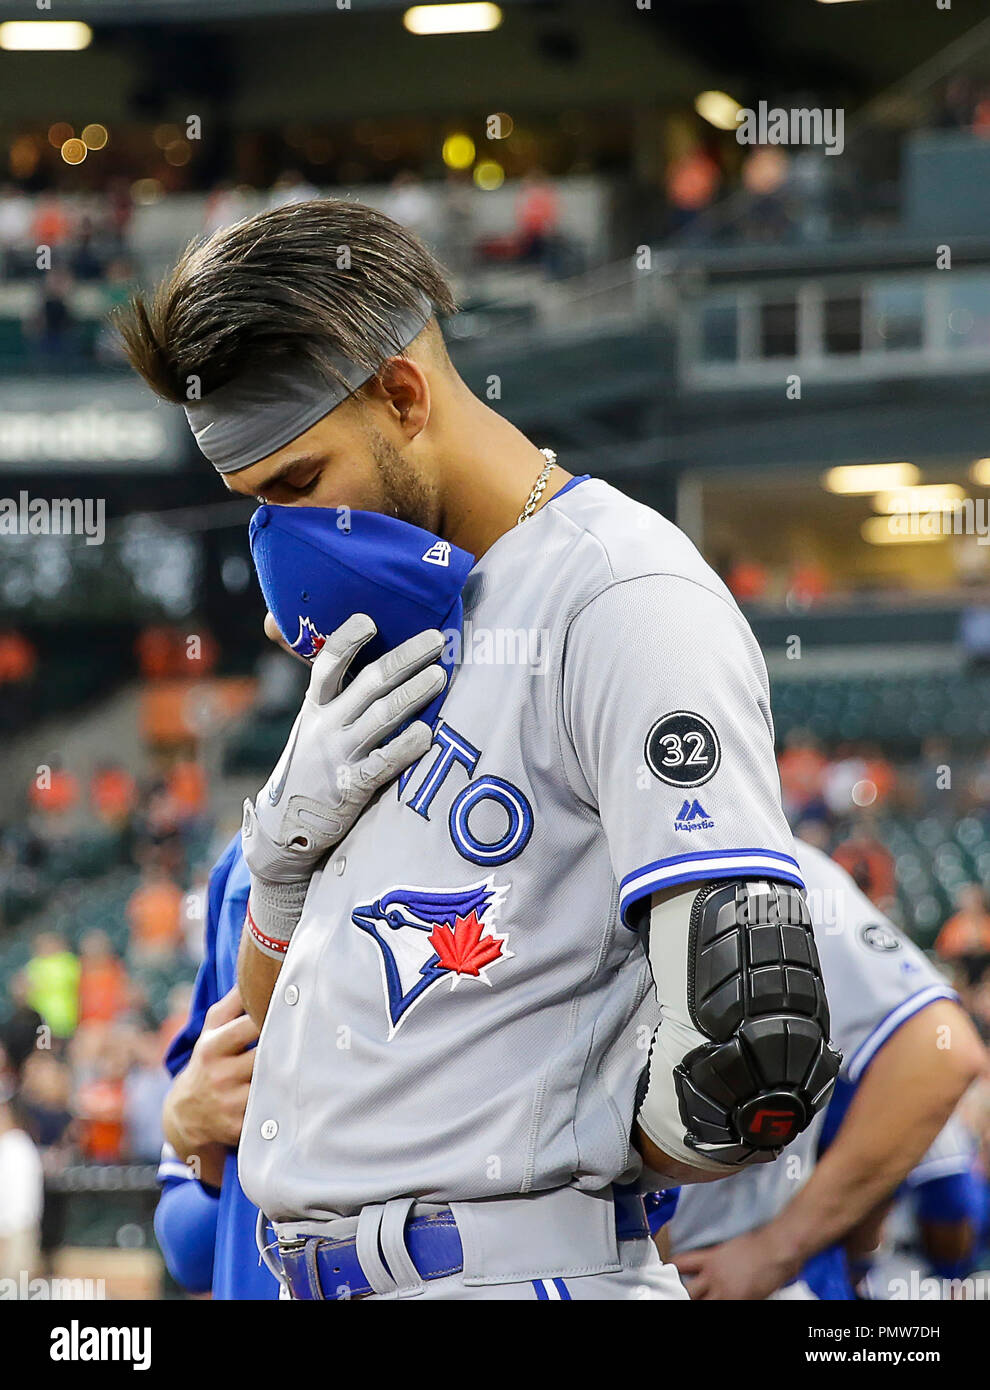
[350, 877, 513, 1038]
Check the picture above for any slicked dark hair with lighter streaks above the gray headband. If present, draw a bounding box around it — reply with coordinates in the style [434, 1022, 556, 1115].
[115, 199, 455, 402]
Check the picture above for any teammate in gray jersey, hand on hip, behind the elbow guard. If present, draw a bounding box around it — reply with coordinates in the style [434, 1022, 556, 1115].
[653, 841, 986, 1300]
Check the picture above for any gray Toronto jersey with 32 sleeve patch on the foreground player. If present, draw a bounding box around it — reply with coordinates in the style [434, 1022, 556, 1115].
[239, 478, 801, 1220]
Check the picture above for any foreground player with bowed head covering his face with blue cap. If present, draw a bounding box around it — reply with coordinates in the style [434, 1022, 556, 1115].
[122, 202, 838, 1300]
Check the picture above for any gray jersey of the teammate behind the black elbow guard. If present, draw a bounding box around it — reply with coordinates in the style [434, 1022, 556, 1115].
[667, 840, 955, 1251]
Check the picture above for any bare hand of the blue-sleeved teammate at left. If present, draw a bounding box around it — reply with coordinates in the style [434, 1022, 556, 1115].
[167, 986, 259, 1159]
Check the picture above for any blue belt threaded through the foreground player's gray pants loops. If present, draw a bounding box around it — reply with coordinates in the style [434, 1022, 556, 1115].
[278, 1188, 649, 1302]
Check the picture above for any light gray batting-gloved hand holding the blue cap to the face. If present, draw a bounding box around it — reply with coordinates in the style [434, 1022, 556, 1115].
[241, 613, 446, 883]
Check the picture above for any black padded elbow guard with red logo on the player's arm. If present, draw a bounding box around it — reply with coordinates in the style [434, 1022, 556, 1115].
[674, 881, 841, 1165]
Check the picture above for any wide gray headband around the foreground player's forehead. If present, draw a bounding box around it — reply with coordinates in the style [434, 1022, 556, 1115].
[185, 297, 432, 473]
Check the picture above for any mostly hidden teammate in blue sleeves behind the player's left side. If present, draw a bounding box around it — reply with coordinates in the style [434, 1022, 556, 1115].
[154, 835, 278, 1300]
